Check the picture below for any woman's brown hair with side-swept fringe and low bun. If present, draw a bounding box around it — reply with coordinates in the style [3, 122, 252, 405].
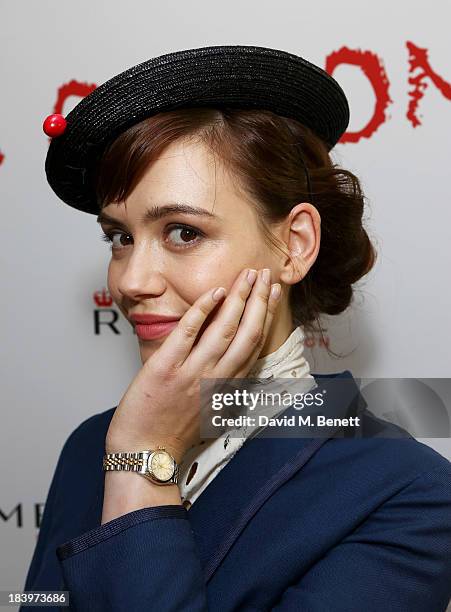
[96, 108, 376, 352]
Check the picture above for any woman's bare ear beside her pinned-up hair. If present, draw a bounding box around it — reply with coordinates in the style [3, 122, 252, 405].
[279, 202, 321, 285]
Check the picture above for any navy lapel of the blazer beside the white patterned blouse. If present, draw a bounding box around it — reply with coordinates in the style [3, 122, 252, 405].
[188, 370, 361, 582]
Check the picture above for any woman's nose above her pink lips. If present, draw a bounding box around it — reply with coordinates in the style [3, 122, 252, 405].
[117, 245, 166, 301]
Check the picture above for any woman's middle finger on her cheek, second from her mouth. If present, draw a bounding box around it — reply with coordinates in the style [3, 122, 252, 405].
[187, 269, 255, 372]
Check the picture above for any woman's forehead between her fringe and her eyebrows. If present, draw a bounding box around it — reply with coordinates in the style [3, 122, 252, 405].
[99, 140, 255, 223]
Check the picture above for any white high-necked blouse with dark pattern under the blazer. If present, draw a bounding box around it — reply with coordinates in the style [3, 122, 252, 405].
[179, 326, 316, 508]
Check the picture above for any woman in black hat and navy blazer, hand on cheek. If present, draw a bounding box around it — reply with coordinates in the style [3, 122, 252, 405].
[25, 46, 451, 612]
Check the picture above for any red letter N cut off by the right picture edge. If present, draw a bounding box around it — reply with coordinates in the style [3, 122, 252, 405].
[406, 41, 451, 127]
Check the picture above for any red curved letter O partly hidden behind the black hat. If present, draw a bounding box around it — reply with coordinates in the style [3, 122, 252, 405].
[325, 47, 392, 143]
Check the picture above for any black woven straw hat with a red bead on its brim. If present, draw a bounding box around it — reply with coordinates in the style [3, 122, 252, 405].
[44, 45, 349, 214]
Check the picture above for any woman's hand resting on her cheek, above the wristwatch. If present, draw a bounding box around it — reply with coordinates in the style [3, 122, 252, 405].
[106, 268, 279, 463]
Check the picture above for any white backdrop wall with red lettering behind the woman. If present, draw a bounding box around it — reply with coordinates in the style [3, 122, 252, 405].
[0, 0, 451, 604]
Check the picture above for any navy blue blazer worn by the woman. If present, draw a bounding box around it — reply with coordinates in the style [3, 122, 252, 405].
[21, 370, 451, 612]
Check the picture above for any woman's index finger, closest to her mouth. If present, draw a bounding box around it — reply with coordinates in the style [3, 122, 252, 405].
[152, 287, 227, 373]
